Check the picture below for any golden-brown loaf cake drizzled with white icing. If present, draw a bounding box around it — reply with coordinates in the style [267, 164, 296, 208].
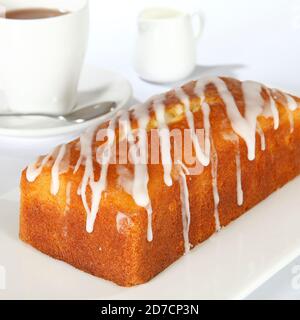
[20, 77, 300, 286]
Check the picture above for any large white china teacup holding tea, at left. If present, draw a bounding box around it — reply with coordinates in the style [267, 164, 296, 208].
[0, 0, 89, 114]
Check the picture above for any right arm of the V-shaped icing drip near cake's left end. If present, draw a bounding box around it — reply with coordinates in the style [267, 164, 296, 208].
[86, 119, 116, 233]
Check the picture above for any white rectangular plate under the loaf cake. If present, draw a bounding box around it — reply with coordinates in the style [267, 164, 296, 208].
[0, 178, 300, 300]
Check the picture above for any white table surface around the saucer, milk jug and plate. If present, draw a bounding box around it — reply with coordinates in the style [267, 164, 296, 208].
[0, 0, 300, 299]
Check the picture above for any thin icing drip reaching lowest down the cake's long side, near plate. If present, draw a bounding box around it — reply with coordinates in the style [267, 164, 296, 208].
[178, 161, 191, 254]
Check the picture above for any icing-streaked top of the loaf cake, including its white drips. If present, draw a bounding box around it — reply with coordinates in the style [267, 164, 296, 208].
[26, 77, 300, 250]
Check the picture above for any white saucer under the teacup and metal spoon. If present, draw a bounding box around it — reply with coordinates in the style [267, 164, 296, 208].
[0, 66, 132, 138]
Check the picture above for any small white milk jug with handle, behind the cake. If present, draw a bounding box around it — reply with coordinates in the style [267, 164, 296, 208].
[135, 7, 203, 83]
